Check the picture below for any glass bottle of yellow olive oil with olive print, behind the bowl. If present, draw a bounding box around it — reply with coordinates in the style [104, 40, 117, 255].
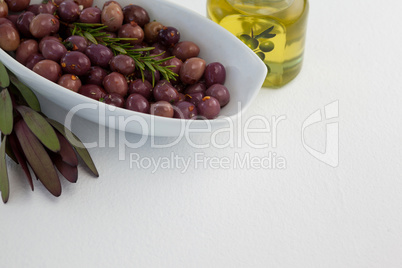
[207, 0, 309, 88]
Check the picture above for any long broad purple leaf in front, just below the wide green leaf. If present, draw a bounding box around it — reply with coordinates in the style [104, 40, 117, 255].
[14, 120, 61, 196]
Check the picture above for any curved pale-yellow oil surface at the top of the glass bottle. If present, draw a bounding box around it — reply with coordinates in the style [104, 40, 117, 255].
[226, 0, 295, 15]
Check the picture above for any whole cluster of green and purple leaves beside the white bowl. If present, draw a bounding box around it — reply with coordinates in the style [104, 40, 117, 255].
[0, 60, 99, 203]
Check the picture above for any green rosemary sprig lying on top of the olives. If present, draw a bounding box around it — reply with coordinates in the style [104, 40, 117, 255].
[69, 22, 177, 85]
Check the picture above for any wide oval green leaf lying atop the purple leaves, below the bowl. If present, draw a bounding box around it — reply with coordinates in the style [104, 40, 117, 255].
[16, 106, 60, 152]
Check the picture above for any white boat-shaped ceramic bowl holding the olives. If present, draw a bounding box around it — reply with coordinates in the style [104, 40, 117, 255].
[0, 0, 267, 136]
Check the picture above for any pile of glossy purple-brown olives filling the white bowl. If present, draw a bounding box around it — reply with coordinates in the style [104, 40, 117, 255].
[0, 0, 230, 119]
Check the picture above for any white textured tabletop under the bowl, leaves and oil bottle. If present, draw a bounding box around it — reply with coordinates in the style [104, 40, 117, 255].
[0, 0, 402, 267]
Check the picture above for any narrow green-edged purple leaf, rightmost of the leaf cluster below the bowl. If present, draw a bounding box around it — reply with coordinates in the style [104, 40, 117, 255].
[47, 118, 99, 177]
